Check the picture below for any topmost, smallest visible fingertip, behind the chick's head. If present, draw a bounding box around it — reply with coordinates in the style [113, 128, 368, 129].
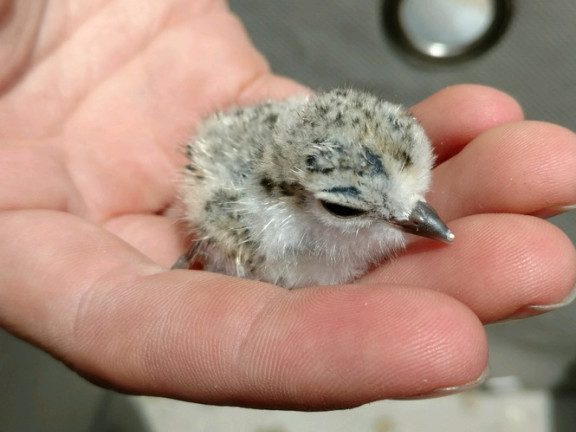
[411, 84, 524, 163]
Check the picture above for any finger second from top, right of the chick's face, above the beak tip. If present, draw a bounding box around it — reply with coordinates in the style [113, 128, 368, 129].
[429, 122, 576, 220]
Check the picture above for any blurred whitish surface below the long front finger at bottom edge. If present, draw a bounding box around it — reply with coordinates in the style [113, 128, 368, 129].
[133, 391, 552, 432]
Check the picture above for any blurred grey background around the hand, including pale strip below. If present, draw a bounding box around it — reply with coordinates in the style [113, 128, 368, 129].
[0, 0, 576, 432]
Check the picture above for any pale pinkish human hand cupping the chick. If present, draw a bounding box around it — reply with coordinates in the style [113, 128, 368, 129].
[0, 0, 576, 409]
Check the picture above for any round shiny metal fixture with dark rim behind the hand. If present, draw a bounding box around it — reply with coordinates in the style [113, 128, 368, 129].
[382, 0, 512, 61]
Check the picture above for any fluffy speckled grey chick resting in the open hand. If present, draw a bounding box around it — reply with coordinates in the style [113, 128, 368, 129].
[175, 89, 454, 288]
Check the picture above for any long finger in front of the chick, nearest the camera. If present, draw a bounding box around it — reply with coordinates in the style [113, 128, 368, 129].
[0, 211, 486, 409]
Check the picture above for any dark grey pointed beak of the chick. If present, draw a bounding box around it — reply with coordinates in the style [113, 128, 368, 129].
[393, 201, 454, 243]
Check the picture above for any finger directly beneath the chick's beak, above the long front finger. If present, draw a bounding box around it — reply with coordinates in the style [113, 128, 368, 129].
[362, 214, 576, 322]
